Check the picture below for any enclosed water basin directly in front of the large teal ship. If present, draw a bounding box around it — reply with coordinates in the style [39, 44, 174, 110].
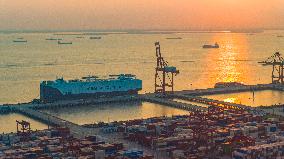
[43, 102, 189, 125]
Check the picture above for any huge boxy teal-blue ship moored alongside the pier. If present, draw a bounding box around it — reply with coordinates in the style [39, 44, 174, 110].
[40, 74, 142, 102]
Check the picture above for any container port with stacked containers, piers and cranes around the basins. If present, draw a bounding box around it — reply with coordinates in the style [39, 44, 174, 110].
[0, 43, 284, 159]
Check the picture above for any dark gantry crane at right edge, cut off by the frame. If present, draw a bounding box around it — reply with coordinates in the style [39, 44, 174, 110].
[259, 52, 284, 84]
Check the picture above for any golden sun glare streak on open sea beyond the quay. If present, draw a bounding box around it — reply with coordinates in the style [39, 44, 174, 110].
[207, 33, 249, 83]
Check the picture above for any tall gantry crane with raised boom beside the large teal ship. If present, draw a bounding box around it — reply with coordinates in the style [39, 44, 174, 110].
[155, 42, 179, 95]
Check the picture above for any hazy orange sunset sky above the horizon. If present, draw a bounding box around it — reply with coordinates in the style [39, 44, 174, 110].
[0, 0, 284, 29]
